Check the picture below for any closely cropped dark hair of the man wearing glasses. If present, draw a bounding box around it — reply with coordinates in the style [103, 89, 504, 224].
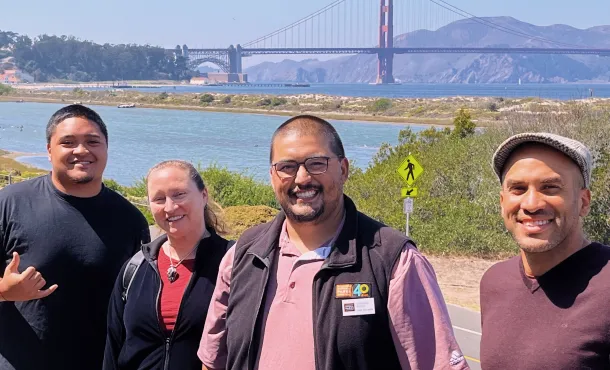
[269, 114, 345, 163]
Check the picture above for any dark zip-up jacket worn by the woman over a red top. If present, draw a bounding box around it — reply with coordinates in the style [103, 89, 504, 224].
[103, 231, 229, 370]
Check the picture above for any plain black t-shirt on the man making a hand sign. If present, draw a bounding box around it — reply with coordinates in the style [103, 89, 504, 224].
[0, 175, 150, 370]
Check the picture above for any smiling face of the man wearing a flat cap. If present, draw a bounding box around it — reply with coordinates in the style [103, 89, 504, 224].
[500, 144, 591, 253]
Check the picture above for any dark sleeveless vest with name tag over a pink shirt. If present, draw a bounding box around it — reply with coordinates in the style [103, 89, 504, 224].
[226, 196, 412, 370]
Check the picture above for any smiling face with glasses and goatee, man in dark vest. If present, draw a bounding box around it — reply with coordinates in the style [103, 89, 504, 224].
[270, 131, 349, 223]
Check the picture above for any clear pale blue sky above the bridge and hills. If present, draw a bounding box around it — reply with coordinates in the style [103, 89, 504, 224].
[0, 0, 610, 66]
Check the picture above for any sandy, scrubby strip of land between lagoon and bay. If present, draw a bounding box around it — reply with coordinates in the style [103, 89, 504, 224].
[0, 85, 610, 129]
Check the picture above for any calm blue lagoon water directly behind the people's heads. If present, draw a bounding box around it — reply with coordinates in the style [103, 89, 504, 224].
[0, 102, 426, 185]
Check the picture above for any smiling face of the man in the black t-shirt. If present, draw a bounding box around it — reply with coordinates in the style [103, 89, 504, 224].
[47, 117, 108, 187]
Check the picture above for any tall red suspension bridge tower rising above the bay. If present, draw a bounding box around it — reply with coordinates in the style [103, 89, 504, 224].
[377, 0, 394, 84]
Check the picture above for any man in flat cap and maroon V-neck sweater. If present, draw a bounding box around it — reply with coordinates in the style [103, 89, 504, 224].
[480, 133, 610, 370]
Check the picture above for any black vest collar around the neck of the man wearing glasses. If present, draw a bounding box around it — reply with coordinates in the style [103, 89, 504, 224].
[247, 195, 359, 268]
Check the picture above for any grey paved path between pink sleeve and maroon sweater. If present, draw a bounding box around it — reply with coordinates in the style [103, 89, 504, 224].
[447, 304, 481, 370]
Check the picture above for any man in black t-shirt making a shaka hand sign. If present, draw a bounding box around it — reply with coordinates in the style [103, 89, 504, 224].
[0, 105, 150, 370]
